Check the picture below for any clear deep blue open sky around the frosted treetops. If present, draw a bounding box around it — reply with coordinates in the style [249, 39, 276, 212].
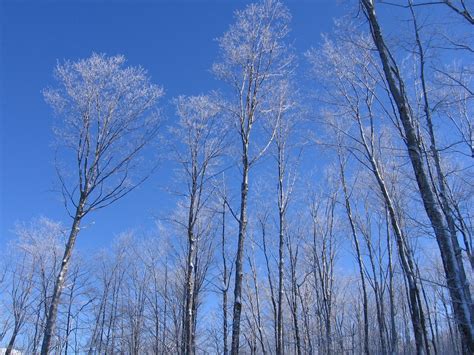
[0, 0, 344, 253]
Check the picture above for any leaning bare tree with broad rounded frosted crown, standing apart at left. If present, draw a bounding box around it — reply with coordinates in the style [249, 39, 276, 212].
[41, 54, 163, 354]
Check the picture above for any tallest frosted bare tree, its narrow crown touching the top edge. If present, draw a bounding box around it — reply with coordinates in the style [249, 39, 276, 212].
[213, 0, 292, 355]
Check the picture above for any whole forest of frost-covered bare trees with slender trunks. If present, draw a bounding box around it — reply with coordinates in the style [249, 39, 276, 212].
[0, 0, 474, 355]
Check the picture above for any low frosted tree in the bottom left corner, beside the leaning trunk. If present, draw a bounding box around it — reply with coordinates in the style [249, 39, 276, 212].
[0, 217, 63, 354]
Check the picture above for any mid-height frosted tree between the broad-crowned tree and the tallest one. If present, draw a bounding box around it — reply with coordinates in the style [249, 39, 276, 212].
[175, 96, 225, 354]
